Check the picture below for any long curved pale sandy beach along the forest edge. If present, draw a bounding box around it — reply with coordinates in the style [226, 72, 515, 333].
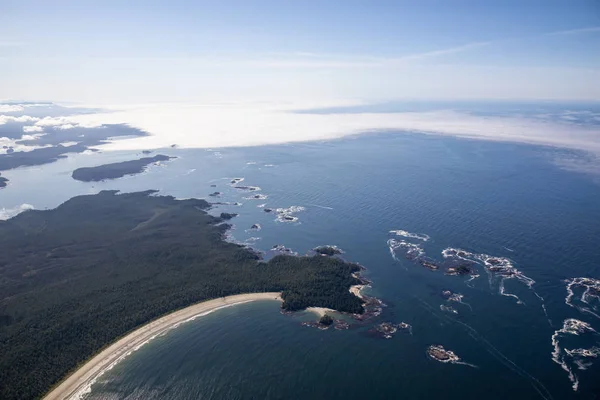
[43, 292, 282, 400]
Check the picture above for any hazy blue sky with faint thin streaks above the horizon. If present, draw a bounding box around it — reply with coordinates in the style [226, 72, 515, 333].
[0, 0, 600, 104]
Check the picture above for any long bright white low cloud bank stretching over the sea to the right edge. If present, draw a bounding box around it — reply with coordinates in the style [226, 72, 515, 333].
[68, 104, 600, 153]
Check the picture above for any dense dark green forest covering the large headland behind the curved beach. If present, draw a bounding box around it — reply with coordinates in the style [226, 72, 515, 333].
[0, 191, 362, 400]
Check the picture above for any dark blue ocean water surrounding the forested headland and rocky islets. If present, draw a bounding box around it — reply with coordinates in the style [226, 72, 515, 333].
[2, 133, 600, 399]
